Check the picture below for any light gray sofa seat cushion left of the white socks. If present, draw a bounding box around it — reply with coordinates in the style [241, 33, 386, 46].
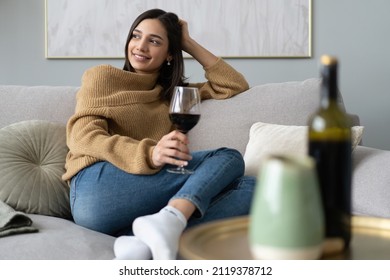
[0, 214, 115, 260]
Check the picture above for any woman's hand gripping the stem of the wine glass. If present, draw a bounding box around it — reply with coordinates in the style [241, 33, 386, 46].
[152, 130, 192, 167]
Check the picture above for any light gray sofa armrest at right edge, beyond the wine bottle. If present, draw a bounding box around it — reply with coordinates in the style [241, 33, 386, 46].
[352, 146, 390, 218]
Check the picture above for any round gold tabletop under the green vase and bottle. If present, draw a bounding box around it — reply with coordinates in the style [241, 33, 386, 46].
[179, 216, 390, 260]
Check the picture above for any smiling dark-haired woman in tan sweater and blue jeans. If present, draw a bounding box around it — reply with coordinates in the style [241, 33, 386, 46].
[63, 9, 255, 259]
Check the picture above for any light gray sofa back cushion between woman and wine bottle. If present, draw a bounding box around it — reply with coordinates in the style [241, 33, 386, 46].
[190, 78, 330, 154]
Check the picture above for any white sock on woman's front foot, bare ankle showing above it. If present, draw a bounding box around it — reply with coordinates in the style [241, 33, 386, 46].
[133, 206, 187, 260]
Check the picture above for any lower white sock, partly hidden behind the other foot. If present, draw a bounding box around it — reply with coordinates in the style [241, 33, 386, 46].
[114, 235, 152, 260]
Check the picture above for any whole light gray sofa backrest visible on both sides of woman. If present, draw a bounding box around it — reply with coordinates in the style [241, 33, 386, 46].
[0, 78, 359, 158]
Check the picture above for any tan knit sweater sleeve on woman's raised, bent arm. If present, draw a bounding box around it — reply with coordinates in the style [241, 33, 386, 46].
[190, 58, 249, 99]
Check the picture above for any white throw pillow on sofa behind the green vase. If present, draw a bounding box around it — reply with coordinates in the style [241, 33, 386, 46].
[244, 122, 364, 176]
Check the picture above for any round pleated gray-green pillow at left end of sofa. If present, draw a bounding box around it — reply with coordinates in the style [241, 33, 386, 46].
[0, 120, 71, 218]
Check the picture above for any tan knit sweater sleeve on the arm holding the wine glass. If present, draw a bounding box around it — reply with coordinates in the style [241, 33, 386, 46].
[67, 109, 159, 174]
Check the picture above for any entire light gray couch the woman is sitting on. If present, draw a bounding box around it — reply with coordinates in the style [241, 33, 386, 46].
[0, 78, 390, 259]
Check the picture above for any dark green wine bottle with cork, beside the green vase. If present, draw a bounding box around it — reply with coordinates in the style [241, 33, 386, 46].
[308, 56, 352, 249]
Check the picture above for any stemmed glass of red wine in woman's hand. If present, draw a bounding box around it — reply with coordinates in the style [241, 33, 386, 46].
[168, 86, 201, 174]
